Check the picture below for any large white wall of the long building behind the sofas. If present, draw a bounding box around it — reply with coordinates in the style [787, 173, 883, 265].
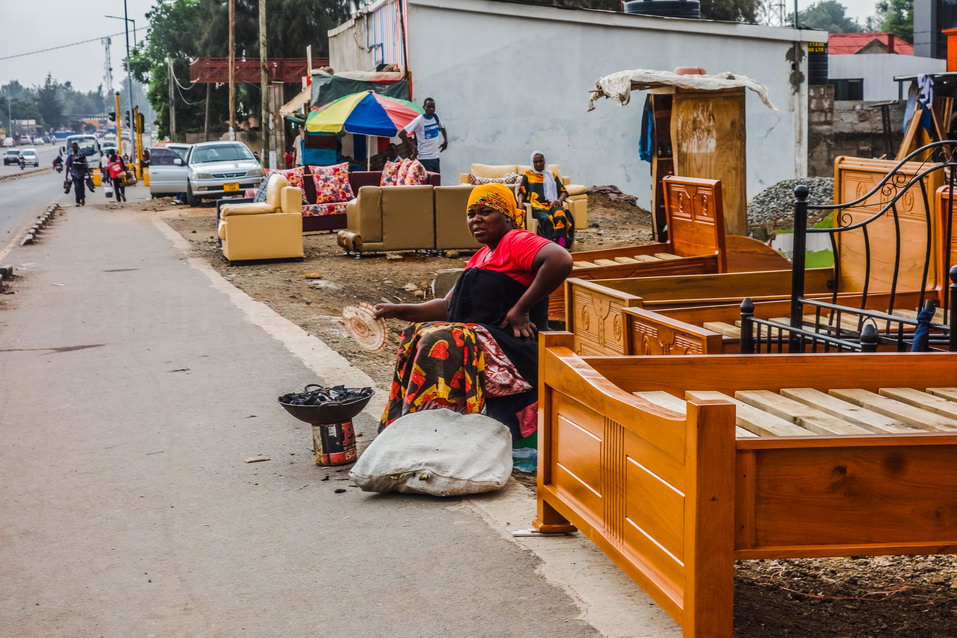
[396, 0, 826, 206]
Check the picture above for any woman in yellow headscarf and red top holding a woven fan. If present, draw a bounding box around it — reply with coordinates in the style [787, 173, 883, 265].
[375, 184, 572, 440]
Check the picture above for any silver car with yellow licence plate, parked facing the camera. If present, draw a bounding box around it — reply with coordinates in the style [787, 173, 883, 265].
[186, 142, 265, 206]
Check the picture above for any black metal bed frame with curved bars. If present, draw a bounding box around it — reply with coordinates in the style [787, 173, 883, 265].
[741, 140, 957, 354]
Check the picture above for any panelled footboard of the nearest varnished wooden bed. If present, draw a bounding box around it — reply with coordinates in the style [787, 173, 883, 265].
[533, 333, 735, 636]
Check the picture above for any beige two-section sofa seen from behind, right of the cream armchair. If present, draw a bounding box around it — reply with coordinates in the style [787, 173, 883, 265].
[337, 184, 479, 256]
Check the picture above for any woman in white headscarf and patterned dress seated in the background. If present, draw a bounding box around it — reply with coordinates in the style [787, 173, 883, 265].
[518, 151, 575, 250]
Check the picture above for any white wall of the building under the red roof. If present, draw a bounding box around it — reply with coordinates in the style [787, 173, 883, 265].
[827, 53, 947, 101]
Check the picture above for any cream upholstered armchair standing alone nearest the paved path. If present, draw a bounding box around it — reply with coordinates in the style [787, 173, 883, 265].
[219, 174, 304, 262]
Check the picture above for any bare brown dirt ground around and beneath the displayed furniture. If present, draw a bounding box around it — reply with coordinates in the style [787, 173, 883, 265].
[99, 197, 957, 638]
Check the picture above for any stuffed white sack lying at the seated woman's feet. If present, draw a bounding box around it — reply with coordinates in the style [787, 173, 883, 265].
[349, 409, 512, 496]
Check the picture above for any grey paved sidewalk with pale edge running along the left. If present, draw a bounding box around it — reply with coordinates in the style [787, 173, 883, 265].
[0, 195, 679, 638]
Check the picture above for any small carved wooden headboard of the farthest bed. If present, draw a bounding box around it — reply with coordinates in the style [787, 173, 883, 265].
[662, 175, 727, 272]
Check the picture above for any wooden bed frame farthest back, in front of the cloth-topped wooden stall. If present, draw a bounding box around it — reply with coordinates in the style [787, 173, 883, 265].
[549, 175, 790, 321]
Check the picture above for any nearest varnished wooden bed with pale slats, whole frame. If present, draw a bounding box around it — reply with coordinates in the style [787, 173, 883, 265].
[534, 333, 957, 638]
